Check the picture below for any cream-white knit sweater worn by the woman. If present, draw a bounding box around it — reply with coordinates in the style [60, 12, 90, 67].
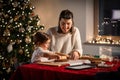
[48, 27, 83, 55]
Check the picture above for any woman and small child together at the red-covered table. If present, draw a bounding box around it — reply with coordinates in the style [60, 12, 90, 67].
[31, 9, 82, 63]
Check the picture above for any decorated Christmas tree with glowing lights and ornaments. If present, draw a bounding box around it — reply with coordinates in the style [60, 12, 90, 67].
[0, 0, 44, 64]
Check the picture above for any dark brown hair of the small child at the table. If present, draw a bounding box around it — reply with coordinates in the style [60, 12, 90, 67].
[33, 32, 50, 44]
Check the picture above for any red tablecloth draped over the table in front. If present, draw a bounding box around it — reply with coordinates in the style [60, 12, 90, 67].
[10, 61, 120, 80]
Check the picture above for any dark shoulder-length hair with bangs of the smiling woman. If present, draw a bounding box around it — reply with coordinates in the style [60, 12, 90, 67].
[58, 9, 74, 33]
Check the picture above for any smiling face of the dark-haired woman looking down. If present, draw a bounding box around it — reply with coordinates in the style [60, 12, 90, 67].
[60, 18, 73, 33]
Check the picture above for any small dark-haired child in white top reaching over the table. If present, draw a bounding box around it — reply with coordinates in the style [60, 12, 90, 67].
[31, 32, 59, 63]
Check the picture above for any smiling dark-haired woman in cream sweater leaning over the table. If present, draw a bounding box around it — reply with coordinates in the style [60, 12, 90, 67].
[48, 9, 82, 60]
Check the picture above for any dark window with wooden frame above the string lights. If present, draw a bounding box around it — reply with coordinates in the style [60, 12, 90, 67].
[94, 0, 120, 43]
